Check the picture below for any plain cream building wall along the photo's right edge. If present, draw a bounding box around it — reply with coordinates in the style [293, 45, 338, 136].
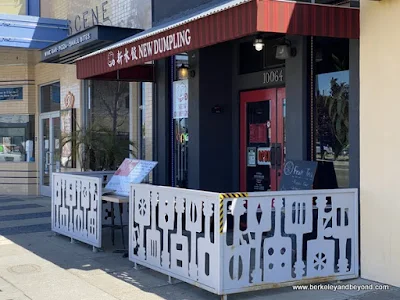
[360, 0, 400, 286]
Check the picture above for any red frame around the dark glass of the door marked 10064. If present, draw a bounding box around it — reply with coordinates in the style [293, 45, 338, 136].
[239, 88, 286, 192]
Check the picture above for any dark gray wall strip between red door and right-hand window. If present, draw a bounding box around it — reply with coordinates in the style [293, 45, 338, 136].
[286, 36, 309, 160]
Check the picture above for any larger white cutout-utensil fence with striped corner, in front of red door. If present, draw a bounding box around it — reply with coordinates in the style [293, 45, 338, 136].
[129, 184, 359, 295]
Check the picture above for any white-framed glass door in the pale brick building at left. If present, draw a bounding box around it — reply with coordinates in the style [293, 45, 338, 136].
[40, 112, 61, 197]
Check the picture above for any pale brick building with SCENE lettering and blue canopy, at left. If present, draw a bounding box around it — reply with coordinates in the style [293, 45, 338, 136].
[0, 0, 152, 195]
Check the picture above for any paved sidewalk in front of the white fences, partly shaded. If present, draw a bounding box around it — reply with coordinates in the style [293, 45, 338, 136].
[0, 195, 400, 300]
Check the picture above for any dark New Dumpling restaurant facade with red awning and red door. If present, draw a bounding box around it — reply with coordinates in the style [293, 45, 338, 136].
[77, 0, 359, 192]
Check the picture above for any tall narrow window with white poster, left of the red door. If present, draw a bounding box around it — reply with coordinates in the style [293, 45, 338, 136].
[172, 55, 189, 188]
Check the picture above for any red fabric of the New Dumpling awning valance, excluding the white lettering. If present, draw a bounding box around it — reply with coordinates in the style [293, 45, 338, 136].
[76, 0, 360, 79]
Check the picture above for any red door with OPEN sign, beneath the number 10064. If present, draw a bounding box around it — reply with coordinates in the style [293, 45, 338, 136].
[240, 88, 286, 192]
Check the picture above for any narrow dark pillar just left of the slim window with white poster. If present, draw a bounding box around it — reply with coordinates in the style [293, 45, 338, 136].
[153, 58, 171, 185]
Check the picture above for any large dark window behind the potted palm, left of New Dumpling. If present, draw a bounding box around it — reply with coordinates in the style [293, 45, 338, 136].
[83, 80, 130, 171]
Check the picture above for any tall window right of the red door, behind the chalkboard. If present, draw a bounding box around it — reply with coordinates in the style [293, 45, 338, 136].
[315, 38, 350, 188]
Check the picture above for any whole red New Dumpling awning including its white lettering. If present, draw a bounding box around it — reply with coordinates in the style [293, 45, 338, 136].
[76, 0, 359, 79]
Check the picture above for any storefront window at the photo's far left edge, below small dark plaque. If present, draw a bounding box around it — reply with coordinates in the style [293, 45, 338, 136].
[0, 115, 35, 163]
